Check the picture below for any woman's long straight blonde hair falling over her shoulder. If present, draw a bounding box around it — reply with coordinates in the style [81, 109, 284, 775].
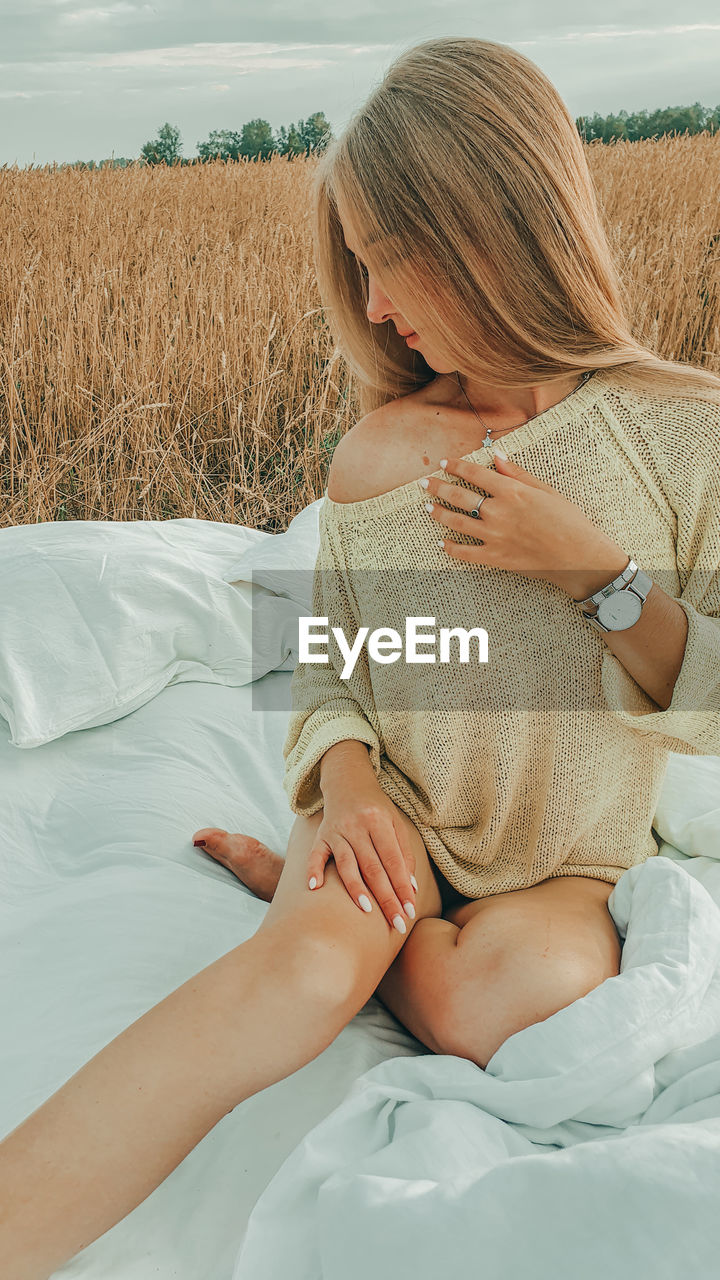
[313, 37, 720, 415]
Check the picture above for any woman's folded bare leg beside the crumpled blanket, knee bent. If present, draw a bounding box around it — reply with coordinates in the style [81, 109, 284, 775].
[366, 876, 623, 1070]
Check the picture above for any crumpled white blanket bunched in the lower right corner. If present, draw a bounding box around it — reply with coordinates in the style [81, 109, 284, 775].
[234, 858, 720, 1280]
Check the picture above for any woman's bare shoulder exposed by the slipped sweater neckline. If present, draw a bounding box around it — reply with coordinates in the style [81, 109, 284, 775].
[328, 378, 437, 502]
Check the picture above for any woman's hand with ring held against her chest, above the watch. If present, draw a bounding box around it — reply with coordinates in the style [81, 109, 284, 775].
[425, 453, 629, 599]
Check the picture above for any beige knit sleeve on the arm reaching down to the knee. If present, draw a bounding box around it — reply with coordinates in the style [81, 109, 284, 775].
[283, 496, 382, 817]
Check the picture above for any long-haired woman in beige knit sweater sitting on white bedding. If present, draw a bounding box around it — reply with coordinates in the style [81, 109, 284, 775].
[0, 38, 720, 1280]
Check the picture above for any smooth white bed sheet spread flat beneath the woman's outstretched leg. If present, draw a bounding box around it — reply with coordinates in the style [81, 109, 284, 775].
[0, 672, 424, 1280]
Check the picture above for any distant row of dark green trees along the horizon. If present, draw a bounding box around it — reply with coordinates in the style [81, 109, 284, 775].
[60, 102, 720, 169]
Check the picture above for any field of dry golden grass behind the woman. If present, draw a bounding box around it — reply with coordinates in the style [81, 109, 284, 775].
[0, 134, 720, 531]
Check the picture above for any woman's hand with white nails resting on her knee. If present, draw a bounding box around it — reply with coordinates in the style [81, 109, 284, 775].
[307, 769, 418, 933]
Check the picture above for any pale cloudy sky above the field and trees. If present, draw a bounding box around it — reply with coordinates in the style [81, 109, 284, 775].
[0, 0, 720, 165]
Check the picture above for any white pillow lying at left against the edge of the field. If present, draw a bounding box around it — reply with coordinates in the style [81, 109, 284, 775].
[0, 520, 288, 748]
